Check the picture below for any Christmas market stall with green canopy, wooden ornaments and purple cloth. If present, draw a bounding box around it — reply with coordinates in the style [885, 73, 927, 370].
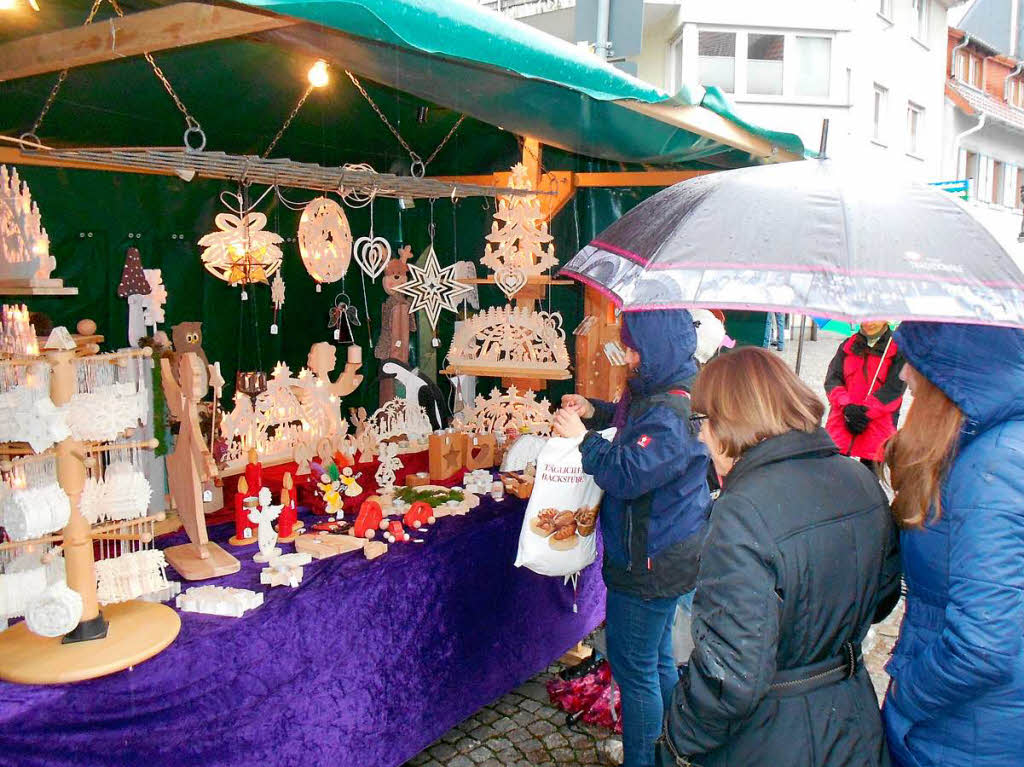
[0, 0, 802, 765]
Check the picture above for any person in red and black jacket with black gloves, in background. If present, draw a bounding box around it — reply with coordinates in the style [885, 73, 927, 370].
[825, 321, 906, 469]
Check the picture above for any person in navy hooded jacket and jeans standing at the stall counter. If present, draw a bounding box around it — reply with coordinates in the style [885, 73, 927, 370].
[555, 309, 711, 767]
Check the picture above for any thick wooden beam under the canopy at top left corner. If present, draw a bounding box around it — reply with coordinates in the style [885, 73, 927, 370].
[0, 2, 298, 82]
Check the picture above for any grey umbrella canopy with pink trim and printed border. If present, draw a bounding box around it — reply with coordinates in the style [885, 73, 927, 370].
[561, 161, 1024, 327]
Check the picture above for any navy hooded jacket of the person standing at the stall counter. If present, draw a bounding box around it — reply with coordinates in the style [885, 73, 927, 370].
[580, 309, 711, 597]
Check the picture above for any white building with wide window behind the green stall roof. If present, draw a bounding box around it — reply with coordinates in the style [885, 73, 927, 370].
[486, 0, 958, 180]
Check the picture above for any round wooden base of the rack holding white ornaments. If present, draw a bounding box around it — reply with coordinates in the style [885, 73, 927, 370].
[0, 601, 181, 684]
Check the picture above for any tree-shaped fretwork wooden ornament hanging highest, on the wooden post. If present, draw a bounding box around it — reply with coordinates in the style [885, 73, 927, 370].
[480, 163, 558, 299]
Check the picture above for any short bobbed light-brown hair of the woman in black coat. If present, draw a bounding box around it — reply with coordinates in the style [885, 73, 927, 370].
[692, 346, 824, 458]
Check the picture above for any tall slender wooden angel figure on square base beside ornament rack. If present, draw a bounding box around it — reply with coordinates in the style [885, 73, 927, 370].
[160, 353, 242, 581]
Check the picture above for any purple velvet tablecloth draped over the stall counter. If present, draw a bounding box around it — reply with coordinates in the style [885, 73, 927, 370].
[0, 498, 604, 767]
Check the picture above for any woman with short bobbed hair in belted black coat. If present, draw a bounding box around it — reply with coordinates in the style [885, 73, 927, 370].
[665, 348, 899, 767]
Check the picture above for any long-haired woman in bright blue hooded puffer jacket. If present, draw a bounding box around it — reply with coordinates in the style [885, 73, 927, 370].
[885, 323, 1024, 767]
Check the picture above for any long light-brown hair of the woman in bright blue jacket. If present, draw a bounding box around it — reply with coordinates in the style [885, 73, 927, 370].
[886, 373, 964, 528]
